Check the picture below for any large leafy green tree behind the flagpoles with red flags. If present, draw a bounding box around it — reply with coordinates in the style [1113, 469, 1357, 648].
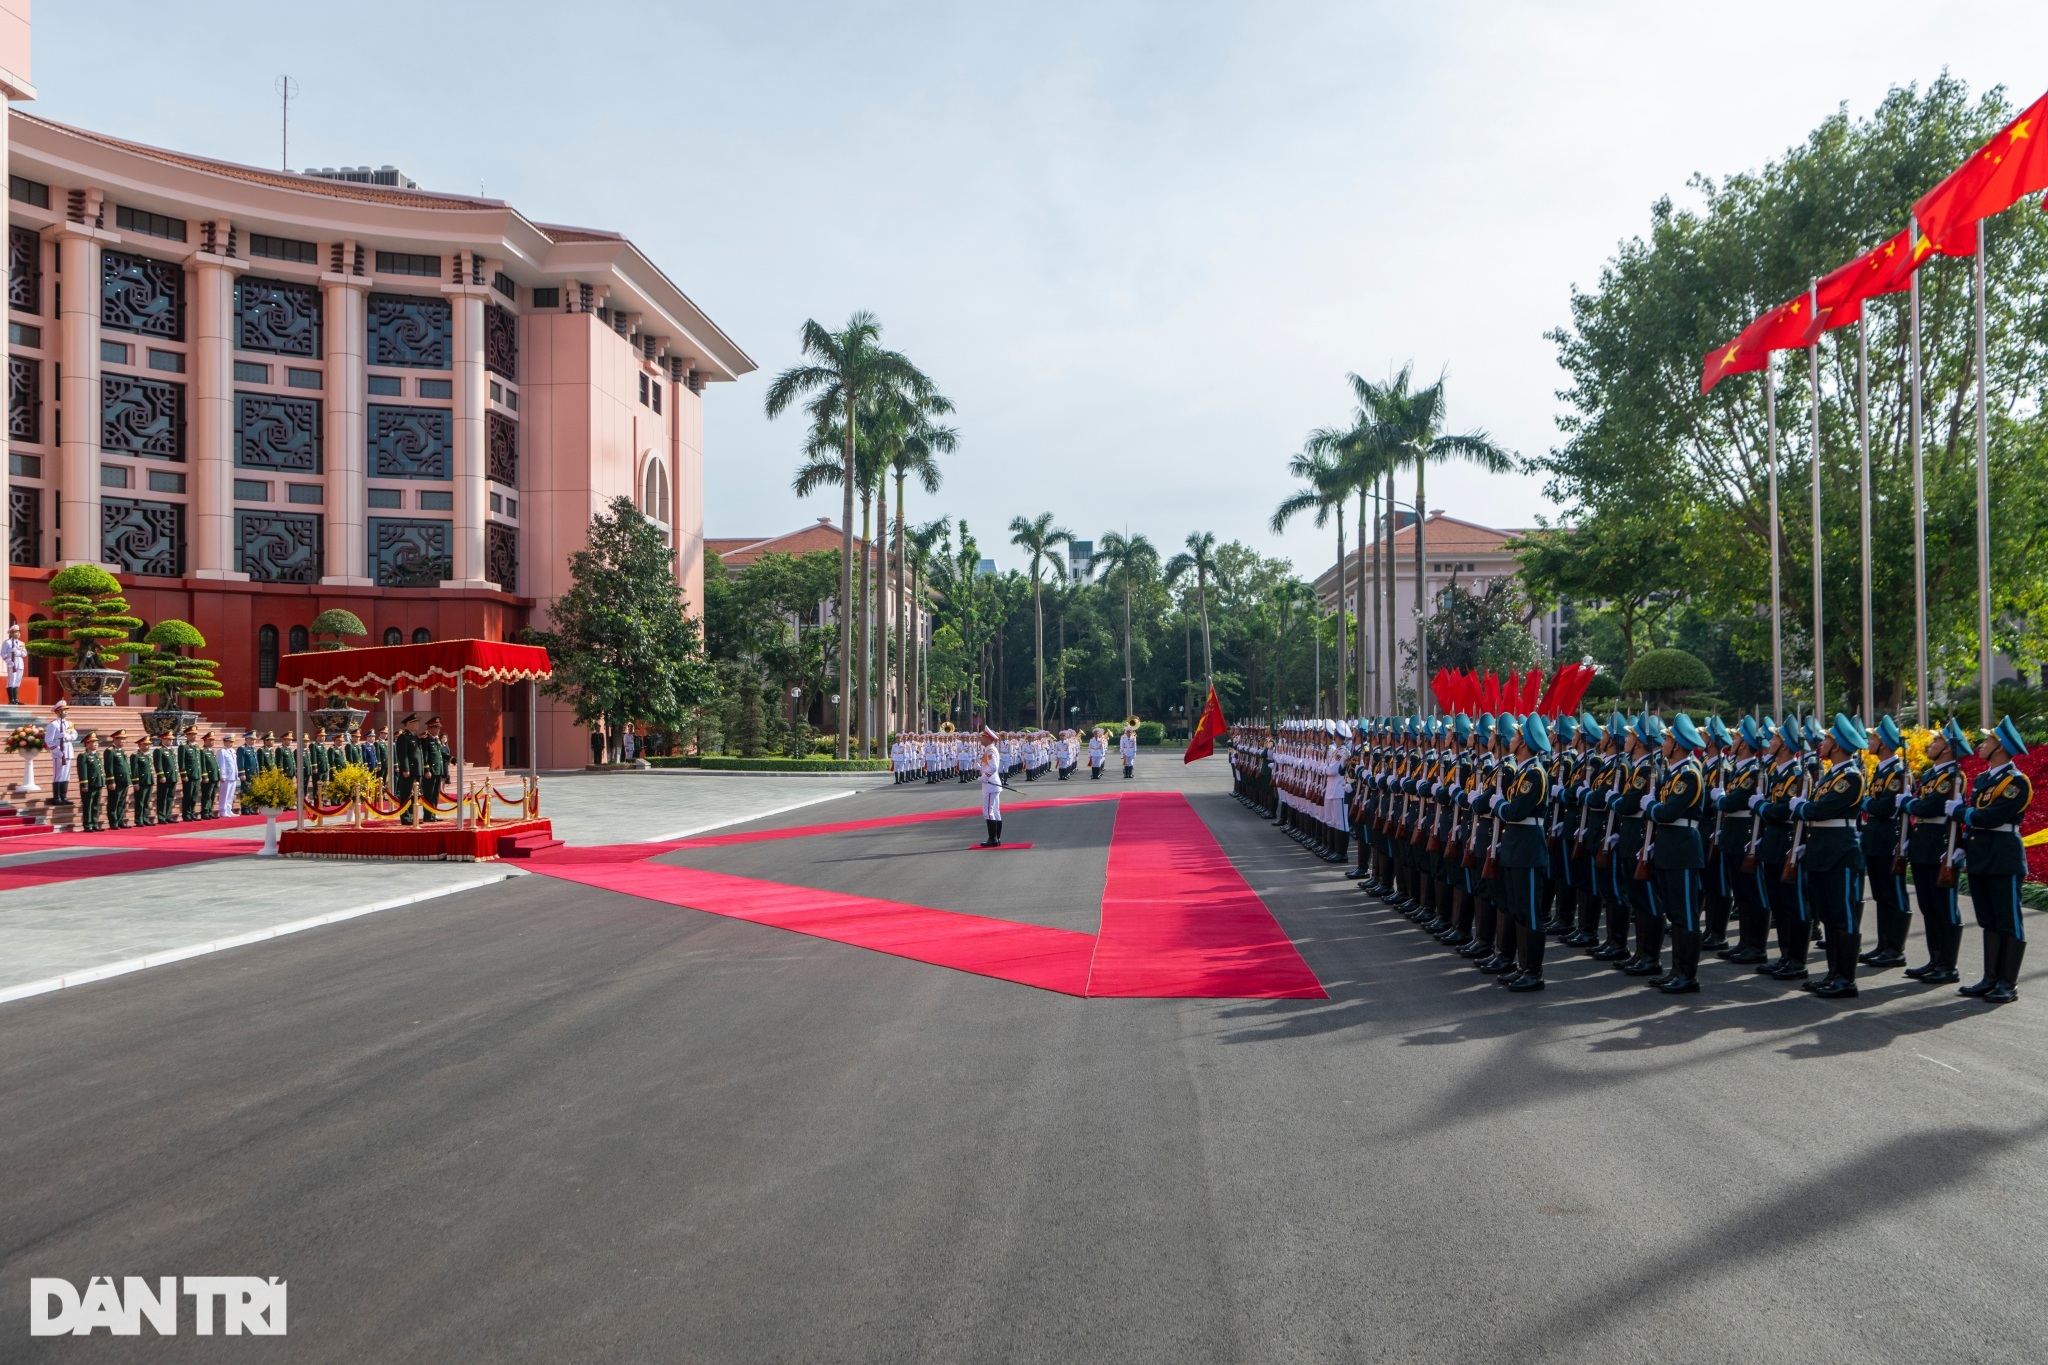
[1528, 76, 2048, 710]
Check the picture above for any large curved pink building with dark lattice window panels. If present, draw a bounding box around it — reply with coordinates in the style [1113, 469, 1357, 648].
[6, 111, 754, 765]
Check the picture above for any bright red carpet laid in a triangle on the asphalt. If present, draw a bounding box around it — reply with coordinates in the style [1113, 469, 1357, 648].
[532, 792, 1323, 999]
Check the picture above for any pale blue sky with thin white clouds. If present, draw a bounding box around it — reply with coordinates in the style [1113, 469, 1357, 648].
[29, 0, 2048, 573]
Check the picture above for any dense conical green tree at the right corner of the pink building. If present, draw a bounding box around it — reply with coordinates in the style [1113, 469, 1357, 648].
[528, 497, 711, 749]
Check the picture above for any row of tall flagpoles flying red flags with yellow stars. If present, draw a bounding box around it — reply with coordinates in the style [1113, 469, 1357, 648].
[1700, 94, 2048, 726]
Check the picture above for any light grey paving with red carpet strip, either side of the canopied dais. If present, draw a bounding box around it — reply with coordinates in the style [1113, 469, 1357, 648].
[0, 772, 889, 1001]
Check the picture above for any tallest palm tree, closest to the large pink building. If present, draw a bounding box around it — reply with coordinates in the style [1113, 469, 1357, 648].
[764, 311, 932, 759]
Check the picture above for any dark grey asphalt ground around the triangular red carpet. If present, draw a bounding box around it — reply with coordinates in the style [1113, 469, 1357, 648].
[0, 755, 2048, 1365]
